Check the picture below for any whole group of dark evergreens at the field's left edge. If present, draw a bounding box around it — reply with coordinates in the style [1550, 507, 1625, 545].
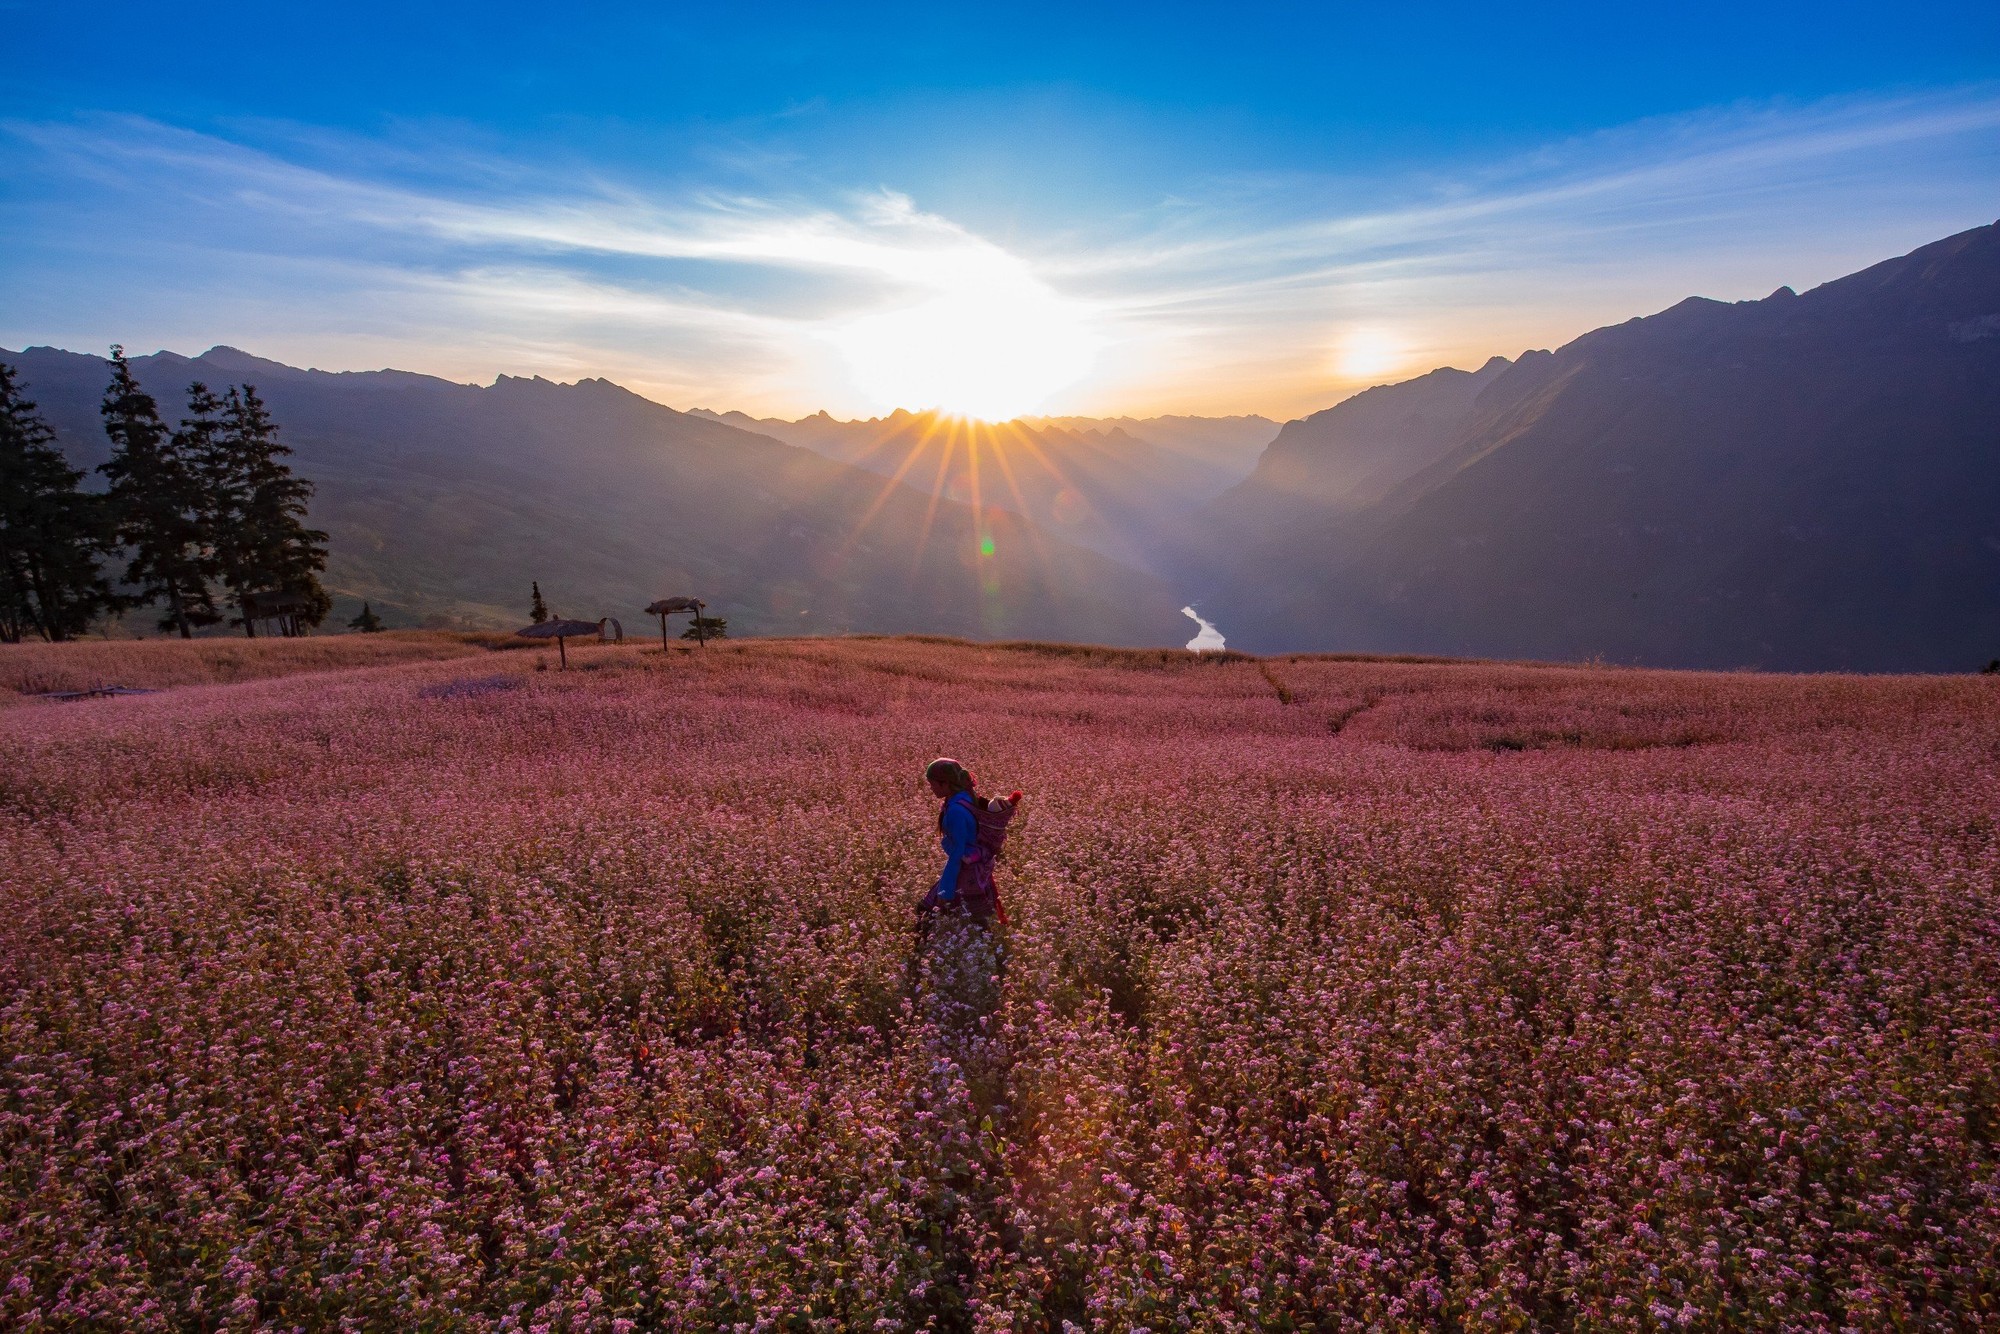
[0, 346, 332, 644]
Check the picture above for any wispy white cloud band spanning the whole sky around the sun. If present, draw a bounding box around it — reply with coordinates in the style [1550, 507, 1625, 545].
[0, 88, 2000, 412]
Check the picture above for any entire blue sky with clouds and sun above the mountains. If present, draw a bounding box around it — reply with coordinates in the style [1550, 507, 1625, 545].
[0, 0, 2000, 416]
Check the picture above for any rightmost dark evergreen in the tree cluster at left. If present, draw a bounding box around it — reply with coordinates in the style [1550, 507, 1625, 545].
[216, 384, 334, 638]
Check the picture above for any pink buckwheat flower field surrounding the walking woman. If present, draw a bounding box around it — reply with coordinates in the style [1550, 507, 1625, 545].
[0, 636, 2000, 1332]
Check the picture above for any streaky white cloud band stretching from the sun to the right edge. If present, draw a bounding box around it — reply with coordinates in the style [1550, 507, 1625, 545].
[1050, 88, 2000, 406]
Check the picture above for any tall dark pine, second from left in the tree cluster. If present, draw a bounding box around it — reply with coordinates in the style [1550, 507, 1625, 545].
[98, 346, 222, 640]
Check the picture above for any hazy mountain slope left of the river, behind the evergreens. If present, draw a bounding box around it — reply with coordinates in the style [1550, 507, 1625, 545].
[0, 348, 1186, 644]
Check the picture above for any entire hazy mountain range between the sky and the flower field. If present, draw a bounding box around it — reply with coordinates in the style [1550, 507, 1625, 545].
[0, 224, 2000, 670]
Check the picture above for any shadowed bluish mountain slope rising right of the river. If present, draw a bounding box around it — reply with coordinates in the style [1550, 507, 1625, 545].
[1184, 226, 2000, 670]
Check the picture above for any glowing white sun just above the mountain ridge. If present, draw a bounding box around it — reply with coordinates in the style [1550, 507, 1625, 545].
[832, 262, 1102, 422]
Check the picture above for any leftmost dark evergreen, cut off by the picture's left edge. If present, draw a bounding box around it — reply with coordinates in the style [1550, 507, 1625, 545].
[0, 364, 118, 644]
